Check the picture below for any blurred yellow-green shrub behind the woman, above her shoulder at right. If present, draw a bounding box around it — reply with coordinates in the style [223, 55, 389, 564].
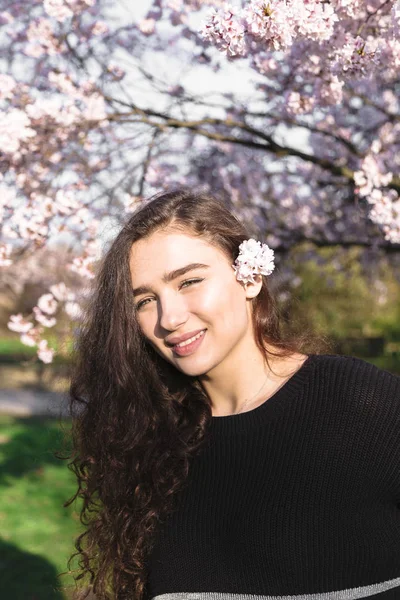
[285, 244, 400, 353]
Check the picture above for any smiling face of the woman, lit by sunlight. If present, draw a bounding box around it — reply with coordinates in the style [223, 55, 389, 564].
[130, 230, 261, 376]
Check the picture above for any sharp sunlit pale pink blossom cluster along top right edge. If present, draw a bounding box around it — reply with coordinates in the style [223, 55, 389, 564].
[200, 0, 400, 86]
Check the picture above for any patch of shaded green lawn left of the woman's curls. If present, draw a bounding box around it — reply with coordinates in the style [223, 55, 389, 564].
[0, 417, 81, 600]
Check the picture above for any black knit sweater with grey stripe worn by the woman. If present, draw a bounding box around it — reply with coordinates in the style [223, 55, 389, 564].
[146, 355, 400, 600]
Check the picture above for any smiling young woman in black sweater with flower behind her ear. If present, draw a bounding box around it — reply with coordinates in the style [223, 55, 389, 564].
[67, 189, 400, 600]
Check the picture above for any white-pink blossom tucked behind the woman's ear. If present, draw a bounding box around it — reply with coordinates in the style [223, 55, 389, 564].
[232, 238, 275, 283]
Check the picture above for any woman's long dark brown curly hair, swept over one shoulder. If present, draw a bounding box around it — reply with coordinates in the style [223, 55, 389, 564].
[62, 188, 324, 600]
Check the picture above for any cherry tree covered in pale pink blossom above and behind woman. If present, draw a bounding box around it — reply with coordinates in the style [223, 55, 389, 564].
[0, 0, 400, 362]
